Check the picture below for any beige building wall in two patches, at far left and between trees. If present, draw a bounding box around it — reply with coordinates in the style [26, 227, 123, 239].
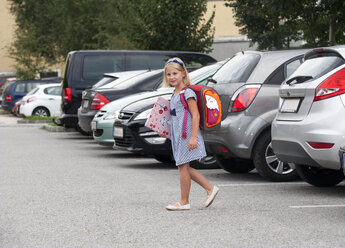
[0, 0, 245, 72]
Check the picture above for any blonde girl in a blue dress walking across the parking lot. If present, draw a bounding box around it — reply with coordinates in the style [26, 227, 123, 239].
[160, 58, 219, 210]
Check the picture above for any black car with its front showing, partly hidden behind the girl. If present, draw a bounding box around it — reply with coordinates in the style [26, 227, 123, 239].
[113, 62, 224, 168]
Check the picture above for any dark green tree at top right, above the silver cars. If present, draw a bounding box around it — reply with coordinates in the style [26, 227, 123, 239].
[226, 0, 345, 49]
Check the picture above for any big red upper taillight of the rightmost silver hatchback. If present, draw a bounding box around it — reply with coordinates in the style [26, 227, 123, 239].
[314, 68, 345, 101]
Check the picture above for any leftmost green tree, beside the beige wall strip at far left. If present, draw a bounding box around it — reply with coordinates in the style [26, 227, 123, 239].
[9, 0, 132, 79]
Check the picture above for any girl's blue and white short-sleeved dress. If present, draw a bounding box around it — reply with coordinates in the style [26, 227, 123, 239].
[170, 88, 206, 166]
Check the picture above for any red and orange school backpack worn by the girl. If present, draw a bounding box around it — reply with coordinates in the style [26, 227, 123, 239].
[180, 85, 222, 139]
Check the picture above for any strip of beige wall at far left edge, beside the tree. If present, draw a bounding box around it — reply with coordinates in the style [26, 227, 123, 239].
[0, 0, 15, 72]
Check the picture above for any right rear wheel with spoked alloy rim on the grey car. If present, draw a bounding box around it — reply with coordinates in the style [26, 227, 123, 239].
[253, 131, 298, 182]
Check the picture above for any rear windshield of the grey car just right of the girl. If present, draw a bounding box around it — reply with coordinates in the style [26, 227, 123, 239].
[212, 53, 260, 84]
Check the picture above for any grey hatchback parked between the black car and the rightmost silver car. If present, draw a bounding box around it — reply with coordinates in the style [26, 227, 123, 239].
[204, 50, 307, 181]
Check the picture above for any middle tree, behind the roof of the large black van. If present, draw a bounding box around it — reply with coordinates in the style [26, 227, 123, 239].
[121, 0, 215, 52]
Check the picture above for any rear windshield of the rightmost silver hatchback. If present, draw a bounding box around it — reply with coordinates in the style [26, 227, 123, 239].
[289, 53, 345, 79]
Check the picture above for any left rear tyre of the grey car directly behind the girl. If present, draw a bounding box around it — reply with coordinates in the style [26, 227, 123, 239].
[216, 156, 254, 173]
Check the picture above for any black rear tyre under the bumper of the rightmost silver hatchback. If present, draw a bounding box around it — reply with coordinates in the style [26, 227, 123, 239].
[296, 165, 344, 187]
